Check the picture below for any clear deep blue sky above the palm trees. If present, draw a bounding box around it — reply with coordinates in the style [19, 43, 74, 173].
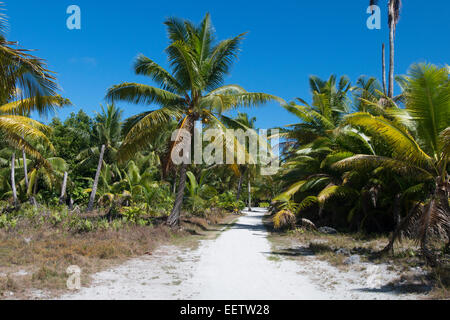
[3, 0, 450, 128]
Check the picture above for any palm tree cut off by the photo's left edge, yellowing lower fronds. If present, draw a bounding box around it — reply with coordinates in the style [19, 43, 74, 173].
[0, 2, 70, 205]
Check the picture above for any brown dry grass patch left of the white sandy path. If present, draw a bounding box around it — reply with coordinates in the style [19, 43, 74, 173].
[0, 209, 236, 299]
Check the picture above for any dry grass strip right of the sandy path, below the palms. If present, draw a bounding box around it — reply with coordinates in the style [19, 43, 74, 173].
[265, 217, 450, 299]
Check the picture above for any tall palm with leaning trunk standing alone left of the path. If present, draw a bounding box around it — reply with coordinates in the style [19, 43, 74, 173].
[107, 14, 279, 226]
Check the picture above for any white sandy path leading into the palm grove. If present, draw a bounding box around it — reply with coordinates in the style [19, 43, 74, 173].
[60, 209, 422, 300]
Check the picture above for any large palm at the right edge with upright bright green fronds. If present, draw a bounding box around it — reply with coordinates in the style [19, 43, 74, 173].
[335, 64, 450, 263]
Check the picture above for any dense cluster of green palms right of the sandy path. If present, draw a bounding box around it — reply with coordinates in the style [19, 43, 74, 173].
[277, 64, 450, 260]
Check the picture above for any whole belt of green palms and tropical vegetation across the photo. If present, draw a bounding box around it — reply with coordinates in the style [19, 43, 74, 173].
[0, 0, 450, 265]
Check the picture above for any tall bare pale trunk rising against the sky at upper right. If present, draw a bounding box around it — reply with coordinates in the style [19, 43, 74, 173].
[370, 0, 402, 99]
